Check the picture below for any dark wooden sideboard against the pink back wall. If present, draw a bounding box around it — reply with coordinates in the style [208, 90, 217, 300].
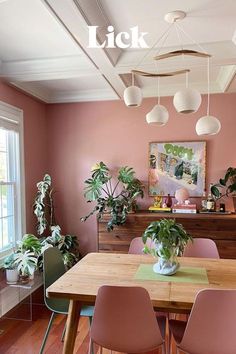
[98, 211, 236, 259]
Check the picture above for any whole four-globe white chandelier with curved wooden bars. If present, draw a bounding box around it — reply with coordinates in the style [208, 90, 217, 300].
[124, 10, 221, 135]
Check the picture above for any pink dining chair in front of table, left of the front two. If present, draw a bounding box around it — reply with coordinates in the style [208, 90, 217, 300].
[90, 285, 166, 354]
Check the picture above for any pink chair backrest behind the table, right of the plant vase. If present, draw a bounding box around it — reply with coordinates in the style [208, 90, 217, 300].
[183, 238, 220, 258]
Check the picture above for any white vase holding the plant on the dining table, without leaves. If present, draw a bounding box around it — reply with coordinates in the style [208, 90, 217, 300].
[153, 244, 180, 275]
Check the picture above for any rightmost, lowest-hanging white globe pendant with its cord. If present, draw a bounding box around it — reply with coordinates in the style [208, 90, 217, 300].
[196, 58, 221, 136]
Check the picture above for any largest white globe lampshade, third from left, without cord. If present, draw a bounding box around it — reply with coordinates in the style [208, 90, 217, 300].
[173, 88, 202, 114]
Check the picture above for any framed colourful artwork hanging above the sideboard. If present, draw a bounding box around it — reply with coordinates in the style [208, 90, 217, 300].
[148, 141, 206, 197]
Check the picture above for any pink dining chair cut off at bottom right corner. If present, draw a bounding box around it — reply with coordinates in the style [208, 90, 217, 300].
[169, 289, 236, 354]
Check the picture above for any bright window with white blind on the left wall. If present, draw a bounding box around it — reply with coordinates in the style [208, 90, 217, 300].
[0, 102, 25, 258]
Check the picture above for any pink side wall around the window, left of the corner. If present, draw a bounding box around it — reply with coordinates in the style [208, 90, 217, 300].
[0, 81, 47, 233]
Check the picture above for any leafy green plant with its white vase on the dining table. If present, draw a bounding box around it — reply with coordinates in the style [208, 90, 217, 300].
[143, 219, 192, 275]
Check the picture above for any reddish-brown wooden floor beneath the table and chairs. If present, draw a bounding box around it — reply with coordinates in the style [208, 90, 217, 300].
[0, 305, 183, 354]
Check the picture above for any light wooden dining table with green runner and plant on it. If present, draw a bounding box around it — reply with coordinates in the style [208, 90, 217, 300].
[47, 253, 236, 354]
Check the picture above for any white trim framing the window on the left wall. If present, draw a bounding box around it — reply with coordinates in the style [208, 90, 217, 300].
[0, 101, 26, 265]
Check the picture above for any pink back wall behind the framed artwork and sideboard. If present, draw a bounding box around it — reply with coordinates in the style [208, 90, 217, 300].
[47, 94, 236, 252]
